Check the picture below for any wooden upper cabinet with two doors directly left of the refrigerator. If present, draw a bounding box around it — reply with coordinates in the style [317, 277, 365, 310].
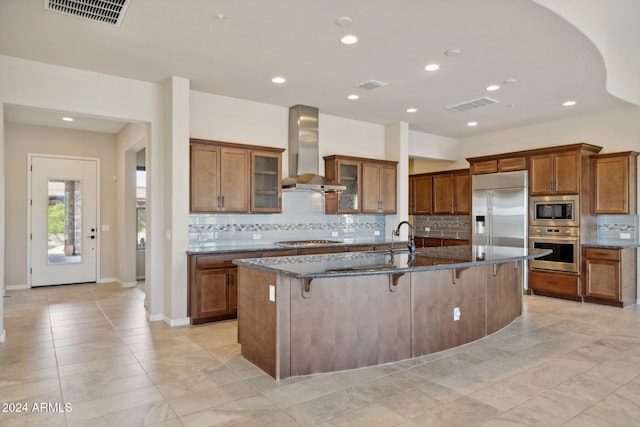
[433, 169, 471, 215]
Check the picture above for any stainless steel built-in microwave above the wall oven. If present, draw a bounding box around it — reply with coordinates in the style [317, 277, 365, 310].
[529, 195, 580, 227]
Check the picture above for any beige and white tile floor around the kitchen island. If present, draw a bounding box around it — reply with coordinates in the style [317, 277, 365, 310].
[0, 284, 640, 427]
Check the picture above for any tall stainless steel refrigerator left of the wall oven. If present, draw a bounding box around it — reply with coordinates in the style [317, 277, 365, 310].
[471, 171, 528, 248]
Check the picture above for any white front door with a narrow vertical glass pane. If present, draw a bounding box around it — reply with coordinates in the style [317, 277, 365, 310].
[30, 155, 98, 286]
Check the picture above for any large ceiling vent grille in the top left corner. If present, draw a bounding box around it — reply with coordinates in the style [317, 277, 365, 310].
[44, 0, 130, 27]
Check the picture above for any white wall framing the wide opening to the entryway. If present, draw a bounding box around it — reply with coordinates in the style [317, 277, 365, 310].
[0, 55, 173, 330]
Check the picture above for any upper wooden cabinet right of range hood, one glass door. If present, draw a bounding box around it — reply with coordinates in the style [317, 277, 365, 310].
[324, 155, 398, 214]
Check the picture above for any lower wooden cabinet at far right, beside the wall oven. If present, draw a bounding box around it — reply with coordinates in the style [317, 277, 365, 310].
[582, 248, 637, 307]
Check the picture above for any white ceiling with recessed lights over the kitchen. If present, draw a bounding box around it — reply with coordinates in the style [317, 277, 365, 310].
[0, 0, 640, 138]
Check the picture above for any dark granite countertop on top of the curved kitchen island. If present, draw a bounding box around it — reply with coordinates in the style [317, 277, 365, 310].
[233, 245, 551, 279]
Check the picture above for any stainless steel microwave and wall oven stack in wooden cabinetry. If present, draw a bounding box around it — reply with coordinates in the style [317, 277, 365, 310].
[529, 195, 580, 273]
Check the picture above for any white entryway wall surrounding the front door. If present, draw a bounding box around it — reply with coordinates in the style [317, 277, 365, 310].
[4, 123, 117, 287]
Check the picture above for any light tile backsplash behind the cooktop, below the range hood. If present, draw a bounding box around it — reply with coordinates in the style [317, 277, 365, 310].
[189, 190, 385, 249]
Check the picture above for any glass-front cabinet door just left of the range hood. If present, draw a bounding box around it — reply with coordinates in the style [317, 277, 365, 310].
[251, 151, 282, 213]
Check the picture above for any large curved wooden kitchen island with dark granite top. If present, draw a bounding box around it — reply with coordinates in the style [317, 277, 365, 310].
[234, 246, 549, 379]
